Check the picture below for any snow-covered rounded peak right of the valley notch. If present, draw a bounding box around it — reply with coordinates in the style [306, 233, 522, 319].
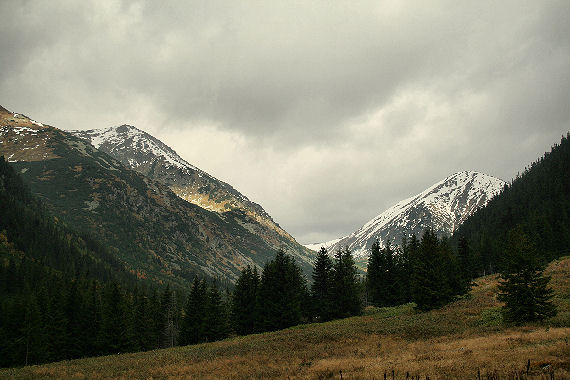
[306, 171, 505, 259]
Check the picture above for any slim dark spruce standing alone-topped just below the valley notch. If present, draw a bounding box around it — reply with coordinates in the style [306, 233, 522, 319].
[311, 247, 334, 322]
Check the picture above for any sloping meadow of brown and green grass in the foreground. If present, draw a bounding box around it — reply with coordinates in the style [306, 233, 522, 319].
[0, 257, 570, 379]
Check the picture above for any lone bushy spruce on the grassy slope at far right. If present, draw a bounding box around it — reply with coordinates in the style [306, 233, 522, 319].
[498, 226, 556, 324]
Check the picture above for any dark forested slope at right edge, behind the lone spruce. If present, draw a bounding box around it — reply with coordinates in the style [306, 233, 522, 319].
[452, 134, 570, 276]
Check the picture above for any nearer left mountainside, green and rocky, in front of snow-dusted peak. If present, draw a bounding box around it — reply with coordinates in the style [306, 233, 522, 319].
[0, 109, 313, 284]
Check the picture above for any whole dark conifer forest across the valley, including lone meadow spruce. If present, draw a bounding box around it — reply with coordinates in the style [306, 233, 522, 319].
[0, 136, 570, 367]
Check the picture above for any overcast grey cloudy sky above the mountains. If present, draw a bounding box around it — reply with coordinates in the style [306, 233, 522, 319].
[0, 0, 570, 243]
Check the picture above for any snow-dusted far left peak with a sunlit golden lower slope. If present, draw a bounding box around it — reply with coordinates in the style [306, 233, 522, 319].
[70, 125, 296, 239]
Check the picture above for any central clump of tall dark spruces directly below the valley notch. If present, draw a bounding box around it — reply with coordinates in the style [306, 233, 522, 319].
[231, 248, 362, 335]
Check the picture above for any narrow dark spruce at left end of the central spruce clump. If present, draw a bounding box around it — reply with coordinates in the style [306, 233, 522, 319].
[231, 265, 260, 335]
